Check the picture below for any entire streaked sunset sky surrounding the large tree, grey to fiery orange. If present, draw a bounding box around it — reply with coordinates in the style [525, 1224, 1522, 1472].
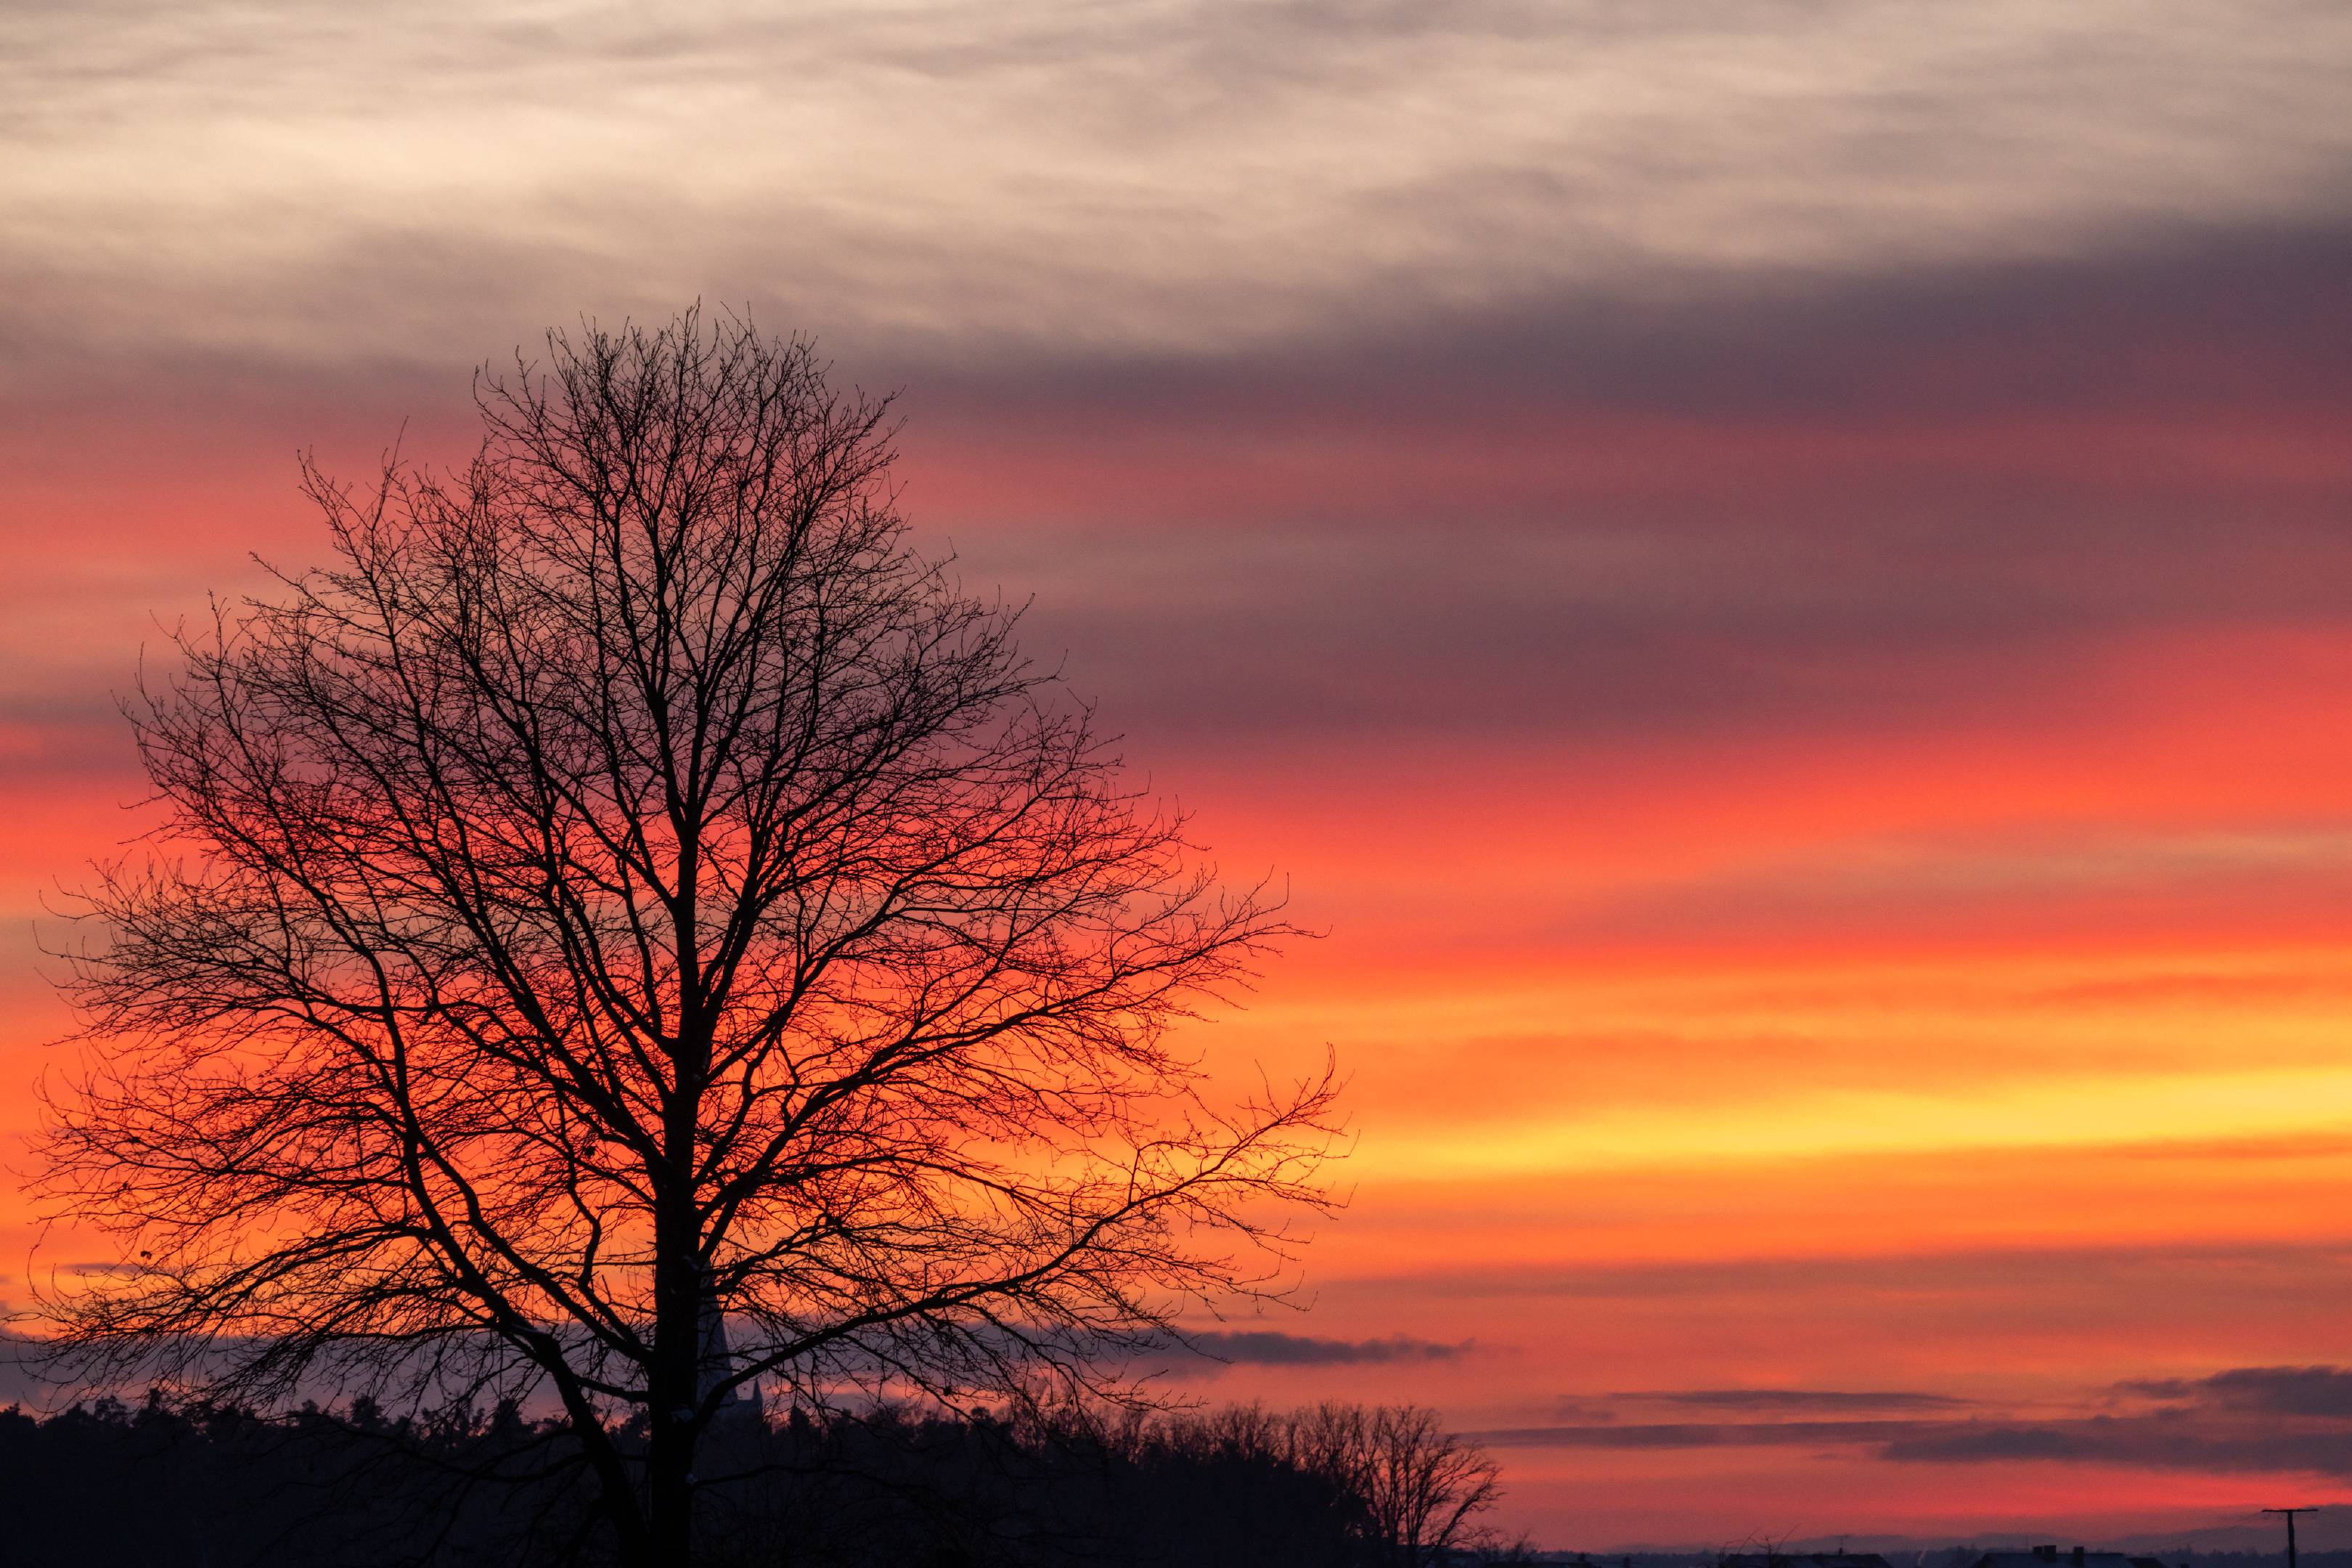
[0, 0, 2352, 1549]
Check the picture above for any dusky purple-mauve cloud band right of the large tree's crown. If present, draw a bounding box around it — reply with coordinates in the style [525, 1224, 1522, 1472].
[908, 228, 2352, 740]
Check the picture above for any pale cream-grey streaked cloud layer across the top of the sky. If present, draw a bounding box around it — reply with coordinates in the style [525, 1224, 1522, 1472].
[0, 0, 2352, 380]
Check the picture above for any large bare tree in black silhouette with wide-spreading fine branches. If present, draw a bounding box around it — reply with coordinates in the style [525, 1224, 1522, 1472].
[45, 313, 1334, 1566]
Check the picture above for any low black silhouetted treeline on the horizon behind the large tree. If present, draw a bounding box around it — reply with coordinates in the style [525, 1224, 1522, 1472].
[0, 1399, 1515, 1568]
